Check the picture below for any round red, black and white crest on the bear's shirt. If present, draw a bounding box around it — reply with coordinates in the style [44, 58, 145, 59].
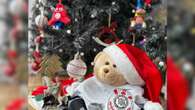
[107, 89, 133, 110]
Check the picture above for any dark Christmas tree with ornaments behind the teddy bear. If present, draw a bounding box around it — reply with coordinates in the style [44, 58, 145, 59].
[29, 0, 167, 80]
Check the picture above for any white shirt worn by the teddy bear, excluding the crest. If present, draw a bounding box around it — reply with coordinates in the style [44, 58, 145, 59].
[75, 76, 144, 110]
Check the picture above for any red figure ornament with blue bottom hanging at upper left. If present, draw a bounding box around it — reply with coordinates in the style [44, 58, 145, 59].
[48, 0, 71, 29]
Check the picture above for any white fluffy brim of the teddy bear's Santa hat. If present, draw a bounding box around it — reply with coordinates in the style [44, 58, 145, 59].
[103, 45, 145, 85]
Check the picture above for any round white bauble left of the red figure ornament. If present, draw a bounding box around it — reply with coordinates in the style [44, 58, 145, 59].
[35, 15, 48, 28]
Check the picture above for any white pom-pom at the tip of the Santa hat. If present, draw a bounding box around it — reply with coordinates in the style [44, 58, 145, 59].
[144, 101, 163, 110]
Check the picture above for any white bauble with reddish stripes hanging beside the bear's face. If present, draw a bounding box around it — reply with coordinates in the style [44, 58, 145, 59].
[66, 53, 87, 79]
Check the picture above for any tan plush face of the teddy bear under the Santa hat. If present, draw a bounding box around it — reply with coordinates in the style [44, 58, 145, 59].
[94, 52, 126, 86]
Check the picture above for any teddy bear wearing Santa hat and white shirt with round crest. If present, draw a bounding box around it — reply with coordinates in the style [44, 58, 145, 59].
[75, 44, 163, 110]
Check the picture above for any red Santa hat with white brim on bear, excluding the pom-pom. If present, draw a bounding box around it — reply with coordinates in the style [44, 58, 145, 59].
[103, 44, 162, 102]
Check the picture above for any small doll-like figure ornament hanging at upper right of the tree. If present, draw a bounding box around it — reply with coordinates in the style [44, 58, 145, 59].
[130, 8, 146, 30]
